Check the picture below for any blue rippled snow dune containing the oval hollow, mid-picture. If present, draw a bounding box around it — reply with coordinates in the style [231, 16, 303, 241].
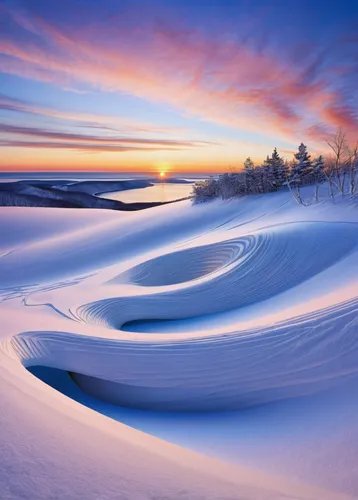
[75, 223, 358, 329]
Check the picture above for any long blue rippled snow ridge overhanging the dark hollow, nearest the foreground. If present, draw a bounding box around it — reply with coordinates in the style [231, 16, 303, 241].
[11, 298, 358, 411]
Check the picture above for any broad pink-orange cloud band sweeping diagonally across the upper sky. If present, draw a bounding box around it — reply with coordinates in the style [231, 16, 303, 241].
[0, 6, 357, 146]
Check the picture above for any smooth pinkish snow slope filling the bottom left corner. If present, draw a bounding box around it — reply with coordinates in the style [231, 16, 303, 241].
[0, 350, 342, 500]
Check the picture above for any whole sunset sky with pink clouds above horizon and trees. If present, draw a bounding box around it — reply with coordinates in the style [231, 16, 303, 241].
[0, 0, 358, 172]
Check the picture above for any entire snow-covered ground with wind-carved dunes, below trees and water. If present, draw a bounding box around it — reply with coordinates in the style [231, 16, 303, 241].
[0, 188, 358, 500]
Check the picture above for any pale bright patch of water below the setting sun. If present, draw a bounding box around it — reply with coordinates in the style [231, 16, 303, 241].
[100, 182, 193, 203]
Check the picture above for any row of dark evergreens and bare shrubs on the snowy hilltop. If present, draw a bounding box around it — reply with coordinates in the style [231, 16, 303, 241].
[192, 130, 358, 204]
